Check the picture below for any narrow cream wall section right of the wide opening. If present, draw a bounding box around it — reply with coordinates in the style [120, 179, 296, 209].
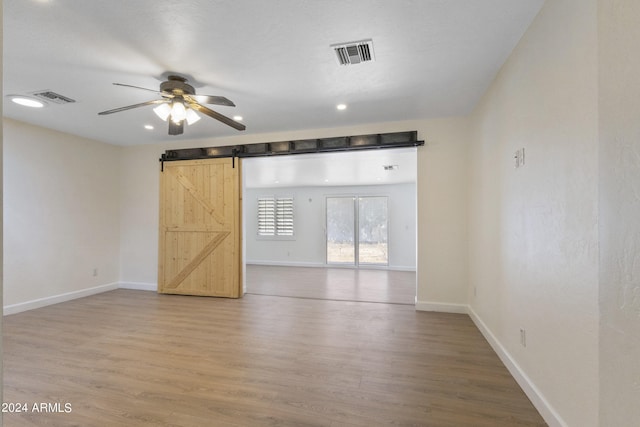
[416, 118, 470, 313]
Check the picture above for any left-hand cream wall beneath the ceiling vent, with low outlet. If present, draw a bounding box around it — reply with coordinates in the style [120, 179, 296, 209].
[3, 119, 121, 312]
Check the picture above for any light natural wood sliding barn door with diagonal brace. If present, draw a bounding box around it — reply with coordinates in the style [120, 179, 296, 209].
[158, 158, 242, 298]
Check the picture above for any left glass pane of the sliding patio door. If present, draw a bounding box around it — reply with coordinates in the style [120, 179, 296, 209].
[327, 197, 356, 265]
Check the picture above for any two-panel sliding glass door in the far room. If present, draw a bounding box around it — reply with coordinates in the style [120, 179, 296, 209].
[326, 196, 389, 266]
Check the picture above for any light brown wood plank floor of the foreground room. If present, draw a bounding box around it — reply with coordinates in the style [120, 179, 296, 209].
[4, 290, 545, 427]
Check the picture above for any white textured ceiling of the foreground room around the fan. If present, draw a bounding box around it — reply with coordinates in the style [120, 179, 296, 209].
[3, 0, 543, 147]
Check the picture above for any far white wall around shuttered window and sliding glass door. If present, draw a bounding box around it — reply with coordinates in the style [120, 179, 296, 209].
[244, 184, 416, 271]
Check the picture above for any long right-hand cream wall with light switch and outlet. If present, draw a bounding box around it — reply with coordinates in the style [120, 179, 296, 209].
[469, 0, 600, 427]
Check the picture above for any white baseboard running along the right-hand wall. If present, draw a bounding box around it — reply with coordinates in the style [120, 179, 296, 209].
[468, 306, 567, 427]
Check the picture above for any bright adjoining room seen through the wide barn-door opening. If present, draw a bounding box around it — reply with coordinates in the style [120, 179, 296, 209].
[243, 148, 417, 305]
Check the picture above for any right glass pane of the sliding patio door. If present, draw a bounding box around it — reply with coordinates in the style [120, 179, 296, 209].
[358, 197, 389, 265]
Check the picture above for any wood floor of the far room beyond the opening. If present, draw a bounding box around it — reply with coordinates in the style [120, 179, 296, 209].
[246, 265, 416, 305]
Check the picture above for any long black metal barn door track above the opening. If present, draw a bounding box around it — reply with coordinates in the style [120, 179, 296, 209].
[160, 131, 424, 167]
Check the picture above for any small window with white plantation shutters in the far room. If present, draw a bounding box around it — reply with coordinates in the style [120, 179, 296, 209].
[258, 196, 293, 237]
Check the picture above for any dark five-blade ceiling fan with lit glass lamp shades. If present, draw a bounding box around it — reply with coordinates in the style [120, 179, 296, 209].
[98, 75, 246, 135]
